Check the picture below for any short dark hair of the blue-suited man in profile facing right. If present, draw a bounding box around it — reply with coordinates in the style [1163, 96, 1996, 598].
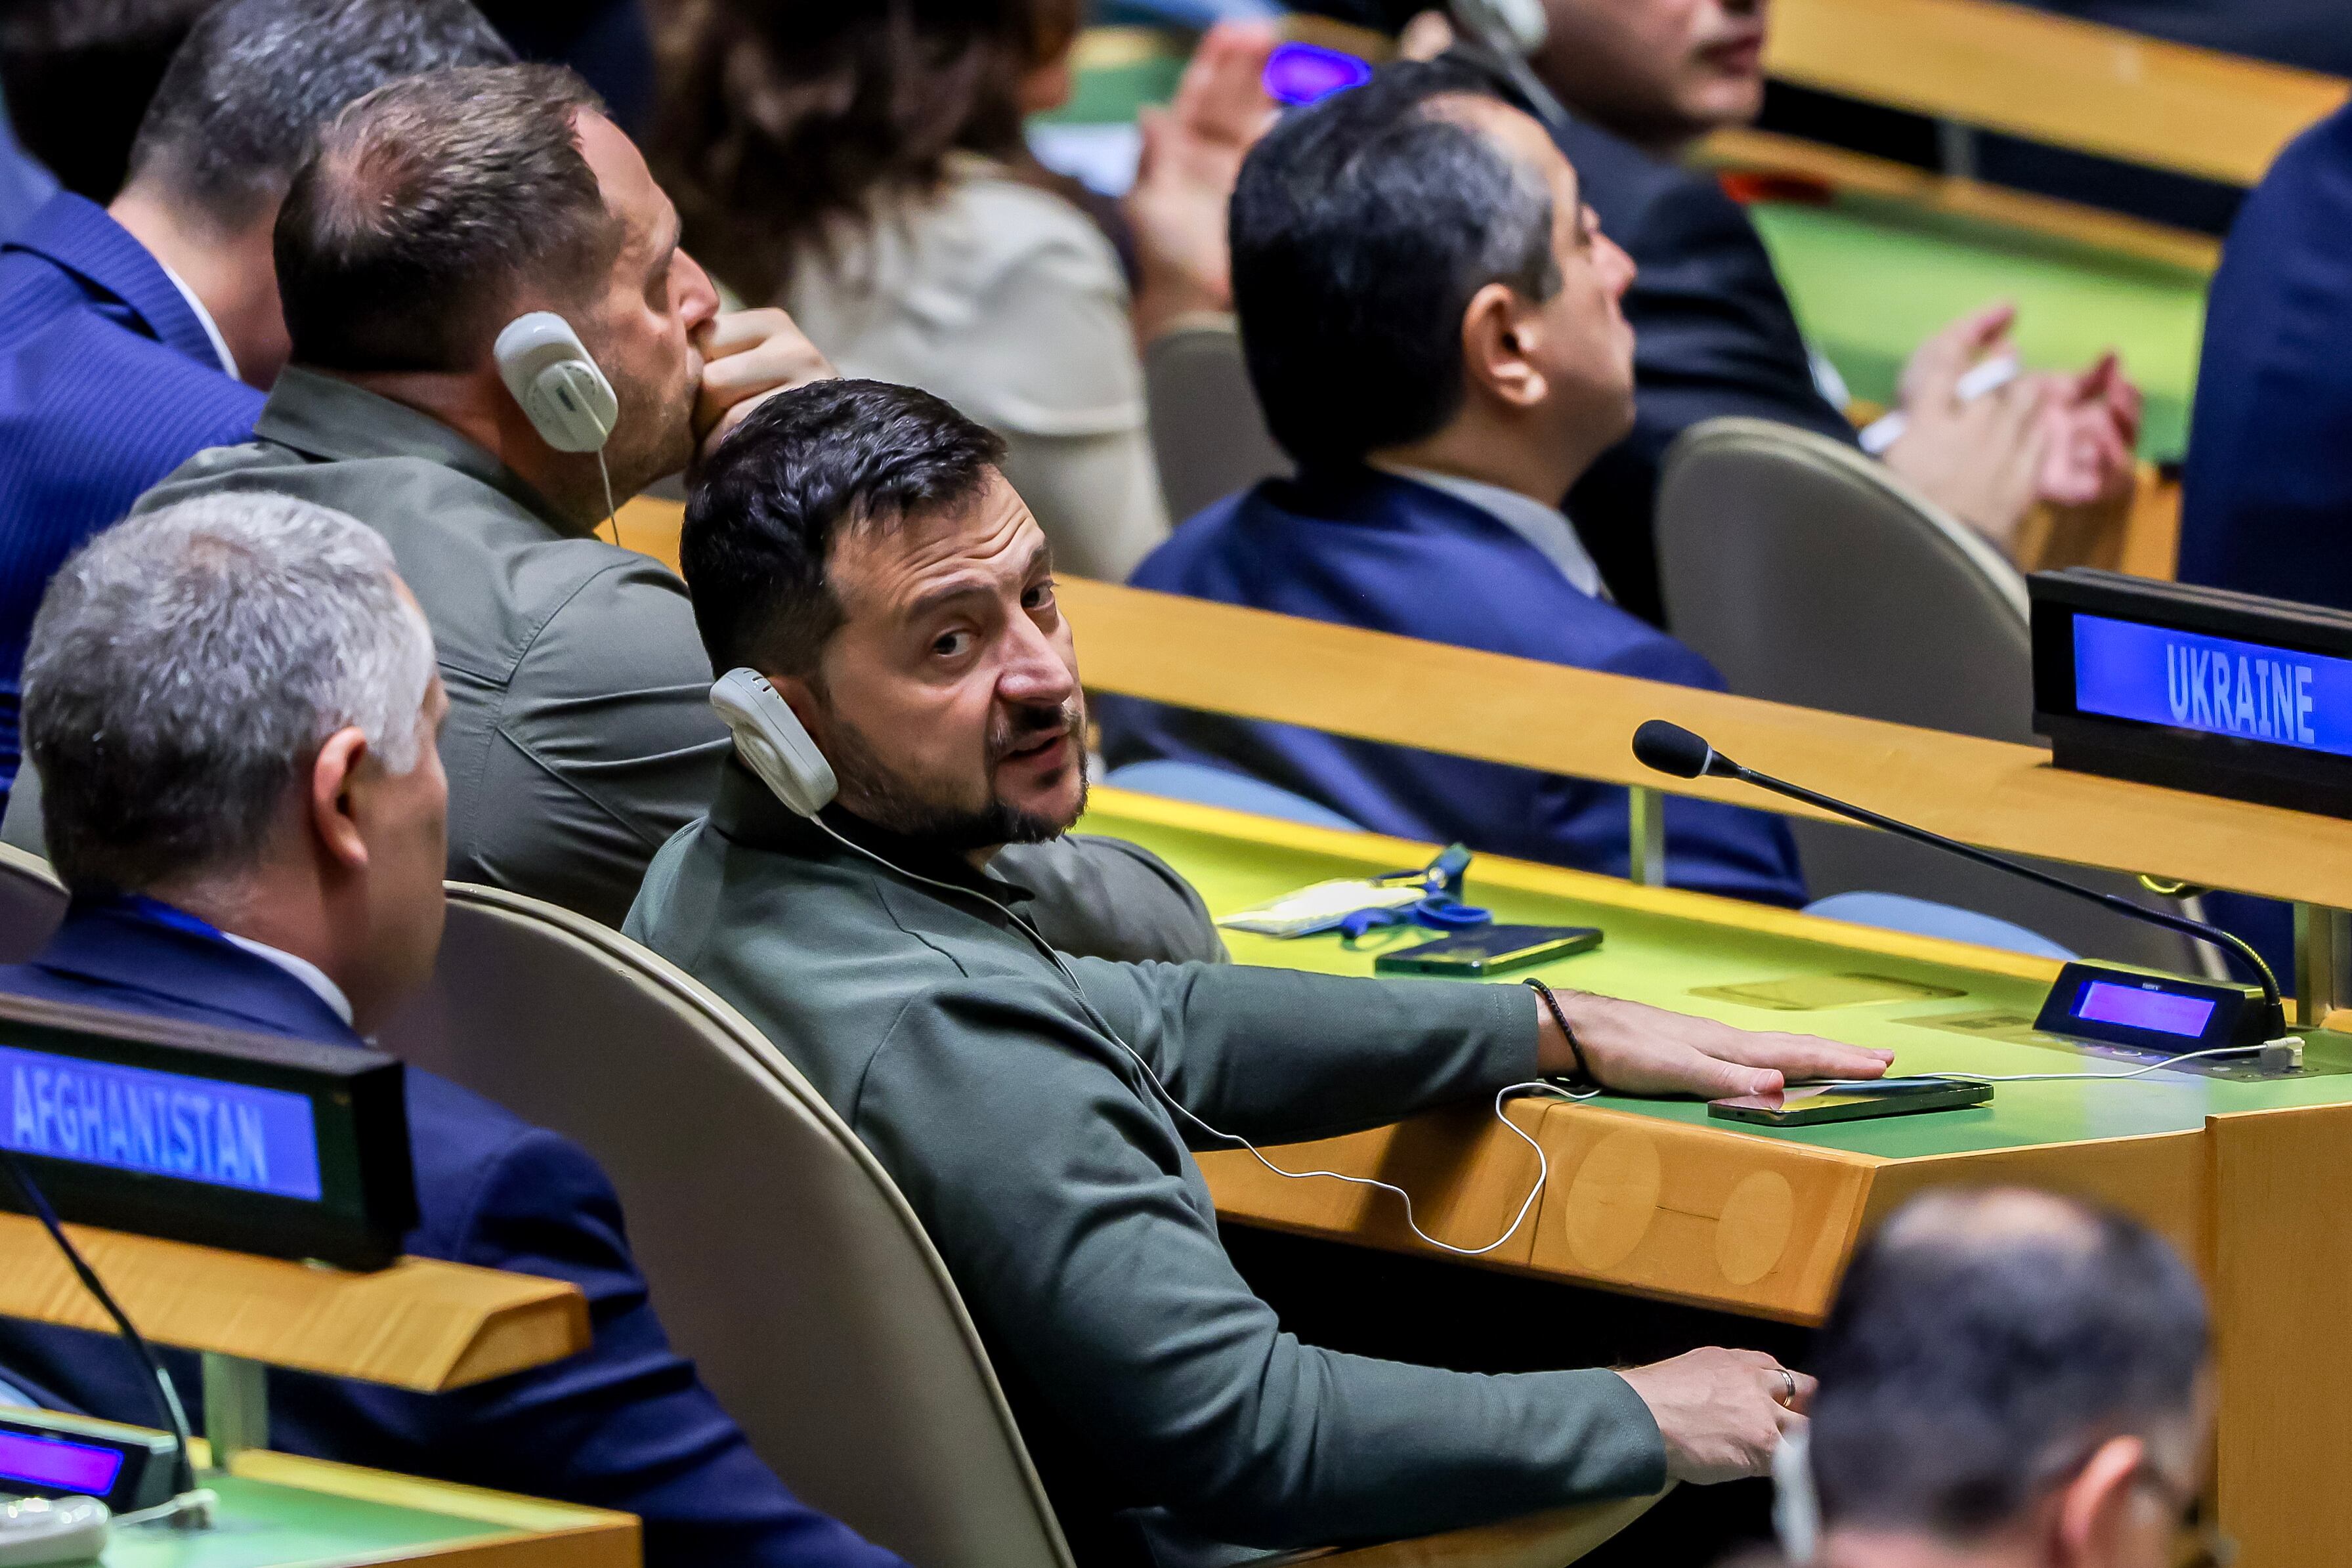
[1230, 61, 1560, 463]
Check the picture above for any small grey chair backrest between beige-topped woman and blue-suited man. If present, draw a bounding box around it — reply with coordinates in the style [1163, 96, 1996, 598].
[1143, 318, 1291, 522]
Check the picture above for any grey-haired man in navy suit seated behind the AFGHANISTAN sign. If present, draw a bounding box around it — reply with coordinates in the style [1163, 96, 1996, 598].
[0, 496, 903, 1568]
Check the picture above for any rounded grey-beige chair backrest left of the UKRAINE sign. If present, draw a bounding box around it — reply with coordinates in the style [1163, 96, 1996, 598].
[1658, 419, 2211, 973]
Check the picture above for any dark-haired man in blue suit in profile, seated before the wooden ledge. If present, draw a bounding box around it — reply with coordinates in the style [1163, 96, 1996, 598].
[1101, 61, 1804, 905]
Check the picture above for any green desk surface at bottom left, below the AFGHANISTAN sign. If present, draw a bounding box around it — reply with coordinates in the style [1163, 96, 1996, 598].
[98, 1476, 515, 1568]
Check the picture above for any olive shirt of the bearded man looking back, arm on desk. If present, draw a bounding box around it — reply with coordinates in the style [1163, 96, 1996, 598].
[623, 764, 1665, 1563]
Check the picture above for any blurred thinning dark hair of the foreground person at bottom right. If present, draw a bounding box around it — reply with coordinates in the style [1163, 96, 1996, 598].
[1811, 1192, 2208, 1542]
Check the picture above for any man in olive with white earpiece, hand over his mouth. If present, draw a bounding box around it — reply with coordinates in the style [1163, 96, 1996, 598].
[85, 66, 1221, 957]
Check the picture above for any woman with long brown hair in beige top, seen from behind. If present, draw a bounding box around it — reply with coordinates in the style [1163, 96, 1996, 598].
[658, 0, 1272, 578]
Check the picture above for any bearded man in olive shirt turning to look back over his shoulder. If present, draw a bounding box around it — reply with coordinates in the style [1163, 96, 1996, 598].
[623, 381, 1887, 1568]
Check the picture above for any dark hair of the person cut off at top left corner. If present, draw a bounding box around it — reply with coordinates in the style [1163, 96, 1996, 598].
[0, 0, 217, 202]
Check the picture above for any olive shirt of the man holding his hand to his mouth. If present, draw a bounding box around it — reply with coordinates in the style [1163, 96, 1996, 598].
[124, 367, 1223, 959]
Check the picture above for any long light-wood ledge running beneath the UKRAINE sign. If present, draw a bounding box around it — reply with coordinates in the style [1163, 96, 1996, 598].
[1061, 578, 2352, 908]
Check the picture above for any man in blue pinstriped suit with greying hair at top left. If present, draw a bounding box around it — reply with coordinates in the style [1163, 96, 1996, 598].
[0, 0, 511, 801]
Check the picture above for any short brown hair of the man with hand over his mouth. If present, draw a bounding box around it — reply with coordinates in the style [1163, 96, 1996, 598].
[275, 66, 621, 371]
